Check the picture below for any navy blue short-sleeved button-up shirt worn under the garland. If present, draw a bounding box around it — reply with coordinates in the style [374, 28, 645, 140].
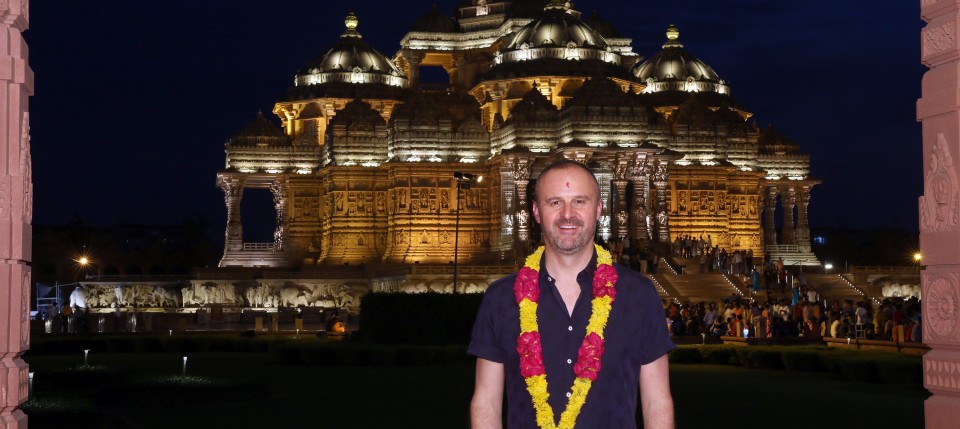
[467, 253, 674, 429]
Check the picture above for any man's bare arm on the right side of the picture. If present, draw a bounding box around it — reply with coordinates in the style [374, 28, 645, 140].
[640, 354, 674, 429]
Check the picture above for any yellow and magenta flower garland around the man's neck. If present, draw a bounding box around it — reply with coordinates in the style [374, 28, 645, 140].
[513, 244, 617, 429]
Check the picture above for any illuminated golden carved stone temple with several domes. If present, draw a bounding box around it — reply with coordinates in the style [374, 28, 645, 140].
[217, 0, 819, 269]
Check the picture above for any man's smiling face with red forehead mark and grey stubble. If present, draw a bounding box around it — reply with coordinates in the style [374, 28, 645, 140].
[533, 167, 601, 255]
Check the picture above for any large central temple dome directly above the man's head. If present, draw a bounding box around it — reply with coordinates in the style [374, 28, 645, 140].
[494, 0, 620, 66]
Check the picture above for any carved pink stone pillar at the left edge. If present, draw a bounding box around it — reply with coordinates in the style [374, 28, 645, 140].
[0, 0, 33, 429]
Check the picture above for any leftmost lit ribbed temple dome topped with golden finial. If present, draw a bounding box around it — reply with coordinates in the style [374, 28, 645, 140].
[294, 13, 409, 92]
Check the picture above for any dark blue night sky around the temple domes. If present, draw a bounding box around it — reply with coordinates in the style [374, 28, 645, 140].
[25, 0, 925, 241]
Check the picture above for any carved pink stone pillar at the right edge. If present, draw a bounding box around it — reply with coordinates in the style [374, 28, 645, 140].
[917, 0, 960, 428]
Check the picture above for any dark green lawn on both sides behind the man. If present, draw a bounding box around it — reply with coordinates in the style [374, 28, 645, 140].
[24, 353, 927, 429]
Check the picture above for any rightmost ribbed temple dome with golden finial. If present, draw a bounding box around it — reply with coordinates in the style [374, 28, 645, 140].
[633, 25, 730, 95]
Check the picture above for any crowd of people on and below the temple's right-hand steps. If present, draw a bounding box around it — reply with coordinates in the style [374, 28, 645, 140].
[576, 234, 921, 342]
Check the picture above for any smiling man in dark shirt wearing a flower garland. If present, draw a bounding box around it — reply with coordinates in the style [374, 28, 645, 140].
[468, 161, 674, 429]
